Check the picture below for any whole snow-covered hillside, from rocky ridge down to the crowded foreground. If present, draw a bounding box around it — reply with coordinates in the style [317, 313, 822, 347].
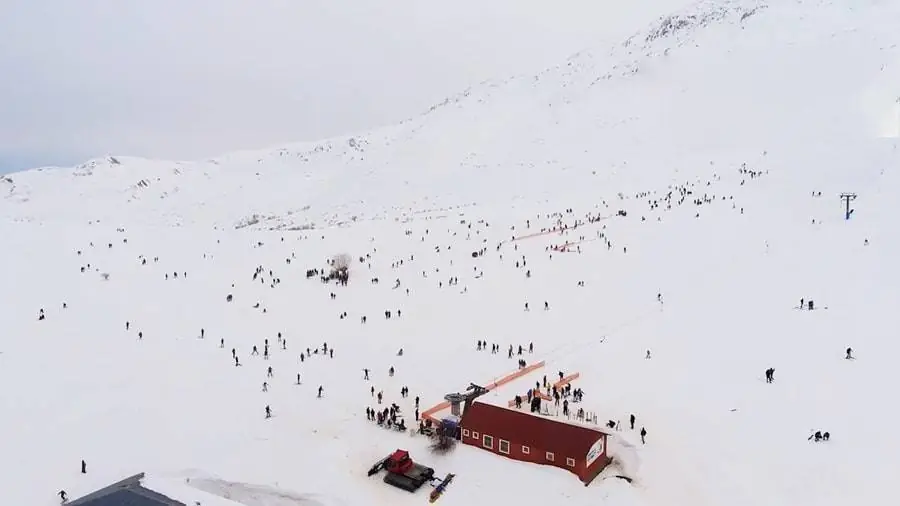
[0, 1, 900, 506]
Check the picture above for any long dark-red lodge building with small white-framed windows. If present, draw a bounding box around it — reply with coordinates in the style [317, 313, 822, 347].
[460, 402, 610, 486]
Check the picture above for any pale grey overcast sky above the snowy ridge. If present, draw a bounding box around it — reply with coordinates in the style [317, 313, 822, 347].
[0, 0, 683, 172]
